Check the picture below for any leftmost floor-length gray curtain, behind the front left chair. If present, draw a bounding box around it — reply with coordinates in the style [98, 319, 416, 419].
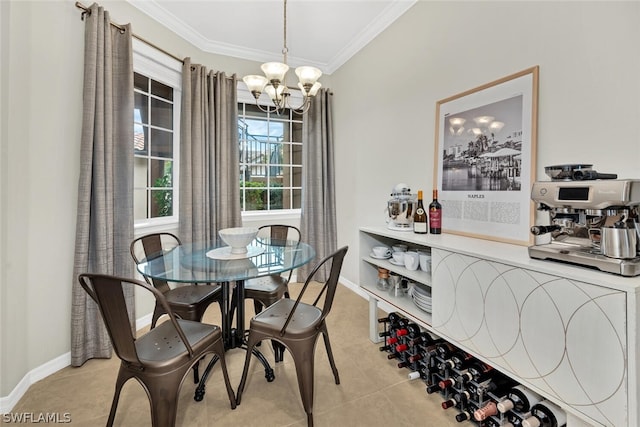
[71, 4, 135, 366]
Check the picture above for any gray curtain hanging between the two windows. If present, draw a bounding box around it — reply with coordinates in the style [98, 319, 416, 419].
[180, 58, 242, 243]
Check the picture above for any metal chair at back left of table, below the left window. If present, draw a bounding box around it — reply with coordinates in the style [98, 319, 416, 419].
[130, 233, 222, 384]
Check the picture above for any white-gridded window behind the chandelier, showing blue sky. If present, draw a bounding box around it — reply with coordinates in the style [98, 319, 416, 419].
[238, 102, 302, 212]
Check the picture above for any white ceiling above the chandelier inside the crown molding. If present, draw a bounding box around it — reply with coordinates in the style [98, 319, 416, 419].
[128, 0, 417, 74]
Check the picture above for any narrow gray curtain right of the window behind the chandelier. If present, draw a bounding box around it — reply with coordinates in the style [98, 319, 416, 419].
[298, 89, 337, 281]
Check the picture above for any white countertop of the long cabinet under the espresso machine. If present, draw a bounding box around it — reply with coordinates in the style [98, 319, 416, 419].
[360, 226, 640, 293]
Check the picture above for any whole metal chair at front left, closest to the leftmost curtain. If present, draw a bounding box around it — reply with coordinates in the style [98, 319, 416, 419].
[78, 274, 236, 427]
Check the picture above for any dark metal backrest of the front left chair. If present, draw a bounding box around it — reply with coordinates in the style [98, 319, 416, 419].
[78, 274, 193, 366]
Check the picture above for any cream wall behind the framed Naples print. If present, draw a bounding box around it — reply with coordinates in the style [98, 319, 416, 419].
[332, 1, 640, 283]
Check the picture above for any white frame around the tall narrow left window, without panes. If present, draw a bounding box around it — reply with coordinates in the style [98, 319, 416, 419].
[131, 39, 182, 232]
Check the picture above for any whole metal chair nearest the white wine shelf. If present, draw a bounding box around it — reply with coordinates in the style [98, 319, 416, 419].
[236, 246, 348, 426]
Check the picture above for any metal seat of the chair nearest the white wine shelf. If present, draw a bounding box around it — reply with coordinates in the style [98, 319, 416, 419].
[250, 298, 322, 338]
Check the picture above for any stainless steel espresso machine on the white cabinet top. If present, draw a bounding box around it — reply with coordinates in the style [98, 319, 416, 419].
[529, 165, 640, 276]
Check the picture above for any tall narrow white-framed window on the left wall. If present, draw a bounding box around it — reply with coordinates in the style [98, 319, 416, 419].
[132, 40, 181, 227]
